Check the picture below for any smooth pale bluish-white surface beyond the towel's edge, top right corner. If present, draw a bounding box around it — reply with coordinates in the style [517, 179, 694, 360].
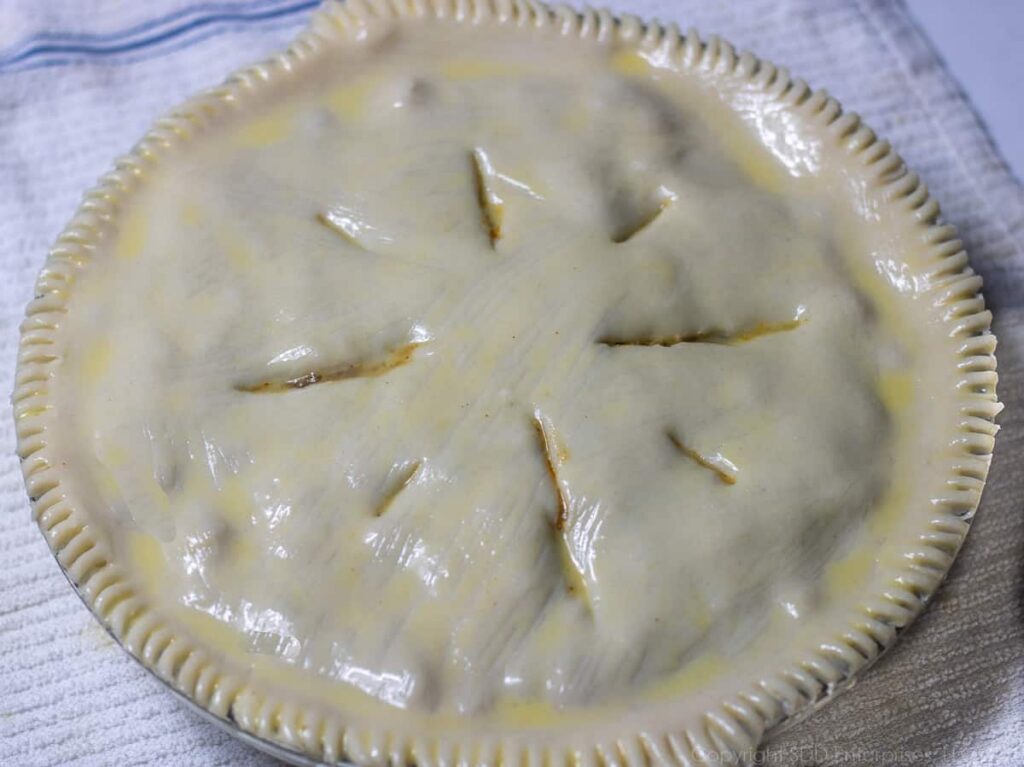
[906, 0, 1024, 179]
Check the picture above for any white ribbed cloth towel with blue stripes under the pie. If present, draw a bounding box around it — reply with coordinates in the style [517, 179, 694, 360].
[0, 0, 1024, 767]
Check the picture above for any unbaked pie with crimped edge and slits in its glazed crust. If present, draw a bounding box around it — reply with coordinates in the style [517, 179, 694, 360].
[14, 0, 999, 765]
